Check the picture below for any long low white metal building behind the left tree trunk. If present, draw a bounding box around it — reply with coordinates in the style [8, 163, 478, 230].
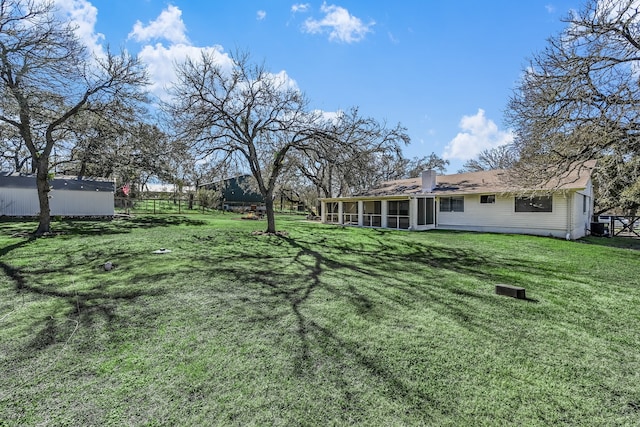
[0, 172, 115, 217]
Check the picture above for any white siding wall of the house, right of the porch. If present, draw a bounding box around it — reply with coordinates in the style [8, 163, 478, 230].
[436, 193, 568, 237]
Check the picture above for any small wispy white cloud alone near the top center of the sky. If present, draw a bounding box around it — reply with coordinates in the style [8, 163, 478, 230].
[302, 3, 375, 43]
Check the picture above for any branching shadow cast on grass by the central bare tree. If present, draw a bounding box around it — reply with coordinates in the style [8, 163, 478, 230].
[190, 235, 559, 420]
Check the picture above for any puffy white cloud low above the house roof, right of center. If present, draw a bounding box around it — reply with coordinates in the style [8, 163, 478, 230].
[442, 109, 513, 160]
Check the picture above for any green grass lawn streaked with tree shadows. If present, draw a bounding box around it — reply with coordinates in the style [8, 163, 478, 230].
[0, 214, 640, 426]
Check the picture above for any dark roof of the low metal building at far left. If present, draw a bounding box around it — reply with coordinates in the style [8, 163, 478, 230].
[0, 171, 115, 192]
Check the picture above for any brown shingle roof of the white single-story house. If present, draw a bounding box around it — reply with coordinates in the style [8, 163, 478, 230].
[344, 162, 595, 197]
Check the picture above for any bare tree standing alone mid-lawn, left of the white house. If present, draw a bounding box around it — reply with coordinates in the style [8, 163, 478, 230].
[166, 53, 319, 233]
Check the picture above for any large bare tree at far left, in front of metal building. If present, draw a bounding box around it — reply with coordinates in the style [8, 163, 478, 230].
[0, 0, 147, 234]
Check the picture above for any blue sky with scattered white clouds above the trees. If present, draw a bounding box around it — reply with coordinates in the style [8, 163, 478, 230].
[56, 0, 582, 173]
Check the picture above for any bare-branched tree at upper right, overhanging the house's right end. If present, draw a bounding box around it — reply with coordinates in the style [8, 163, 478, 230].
[507, 0, 640, 214]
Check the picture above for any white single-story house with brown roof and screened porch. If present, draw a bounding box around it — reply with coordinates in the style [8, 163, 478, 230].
[321, 164, 594, 239]
